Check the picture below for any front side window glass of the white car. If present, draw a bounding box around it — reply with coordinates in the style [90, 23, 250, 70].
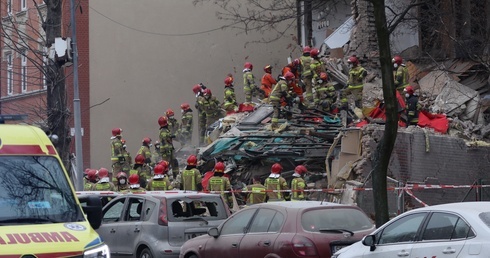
[376, 213, 426, 244]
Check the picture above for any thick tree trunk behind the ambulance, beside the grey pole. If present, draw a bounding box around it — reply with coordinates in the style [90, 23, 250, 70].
[43, 0, 70, 168]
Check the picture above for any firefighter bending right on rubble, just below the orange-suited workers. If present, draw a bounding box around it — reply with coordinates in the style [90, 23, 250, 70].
[269, 72, 299, 130]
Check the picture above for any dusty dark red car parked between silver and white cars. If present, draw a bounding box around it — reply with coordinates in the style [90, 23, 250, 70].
[180, 201, 374, 258]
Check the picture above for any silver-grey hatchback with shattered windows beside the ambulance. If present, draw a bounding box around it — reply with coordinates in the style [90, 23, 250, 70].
[97, 191, 230, 258]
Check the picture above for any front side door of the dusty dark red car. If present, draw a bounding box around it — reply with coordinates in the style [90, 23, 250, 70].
[204, 208, 257, 258]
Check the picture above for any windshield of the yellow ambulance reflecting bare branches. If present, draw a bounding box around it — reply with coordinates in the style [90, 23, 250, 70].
[0, 156, 83, 226]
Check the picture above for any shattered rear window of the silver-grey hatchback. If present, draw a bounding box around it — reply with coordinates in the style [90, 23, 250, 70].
[167, 195, 227, 221]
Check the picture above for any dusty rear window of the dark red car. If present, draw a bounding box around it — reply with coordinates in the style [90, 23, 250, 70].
[301, 208, 373, 233]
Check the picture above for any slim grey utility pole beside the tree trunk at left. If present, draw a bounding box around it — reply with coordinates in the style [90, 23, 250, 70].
[70, 0, 83, 191]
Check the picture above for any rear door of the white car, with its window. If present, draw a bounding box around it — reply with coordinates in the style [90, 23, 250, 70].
[411, 212, 468, 258]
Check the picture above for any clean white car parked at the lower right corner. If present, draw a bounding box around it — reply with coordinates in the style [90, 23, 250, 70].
[332, 202, 490, 258]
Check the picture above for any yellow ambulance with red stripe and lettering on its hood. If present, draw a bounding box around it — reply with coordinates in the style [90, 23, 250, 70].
[0, 124, 110, 258]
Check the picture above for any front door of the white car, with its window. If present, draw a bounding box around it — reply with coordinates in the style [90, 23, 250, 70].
[363, 212, 427, 258]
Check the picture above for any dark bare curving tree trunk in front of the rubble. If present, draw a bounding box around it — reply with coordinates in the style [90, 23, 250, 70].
[371, 0, 398, 227]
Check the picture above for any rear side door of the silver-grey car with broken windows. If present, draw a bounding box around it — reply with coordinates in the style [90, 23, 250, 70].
[117, 196, 145, 256]
